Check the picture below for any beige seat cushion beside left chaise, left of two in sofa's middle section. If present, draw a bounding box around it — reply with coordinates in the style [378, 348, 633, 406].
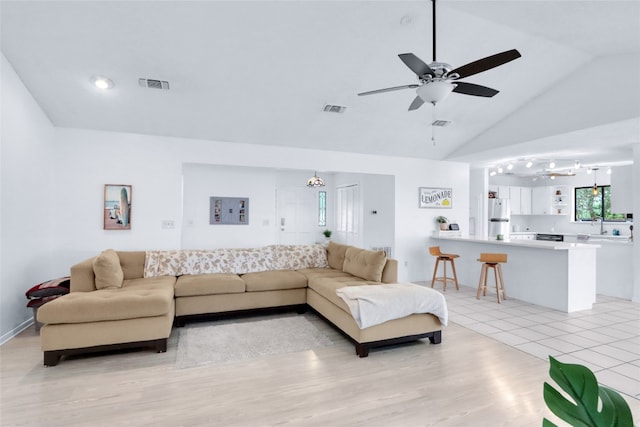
[175, 273, 246, 297]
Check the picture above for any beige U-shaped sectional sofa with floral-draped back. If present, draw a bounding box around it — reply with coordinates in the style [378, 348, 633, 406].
[38, 242, 441, 366]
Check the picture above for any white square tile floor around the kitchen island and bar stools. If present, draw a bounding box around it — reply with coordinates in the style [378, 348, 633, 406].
[419, 282, 640, 400]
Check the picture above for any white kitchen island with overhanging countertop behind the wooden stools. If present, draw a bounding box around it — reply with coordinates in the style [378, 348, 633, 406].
[430, 236, 600, 313]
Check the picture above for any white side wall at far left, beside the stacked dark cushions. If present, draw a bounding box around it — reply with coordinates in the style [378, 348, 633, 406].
[0, 55, 56, 343]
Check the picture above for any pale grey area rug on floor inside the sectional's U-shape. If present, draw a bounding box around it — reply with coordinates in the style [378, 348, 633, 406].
[176, 316, 333, 369]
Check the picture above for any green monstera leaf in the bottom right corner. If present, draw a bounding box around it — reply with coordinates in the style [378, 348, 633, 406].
[542, 356, 633, 427]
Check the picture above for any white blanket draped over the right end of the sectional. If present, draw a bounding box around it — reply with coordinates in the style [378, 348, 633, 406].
[336, 283, 448, 329]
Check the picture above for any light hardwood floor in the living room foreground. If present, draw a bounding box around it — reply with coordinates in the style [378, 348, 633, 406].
[0, 313, 637, 427]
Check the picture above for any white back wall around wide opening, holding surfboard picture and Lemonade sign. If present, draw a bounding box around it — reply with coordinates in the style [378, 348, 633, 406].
[51, 128, 469, 281]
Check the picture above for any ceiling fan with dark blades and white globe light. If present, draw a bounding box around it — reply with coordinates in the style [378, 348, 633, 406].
[358, 0, 521, 111]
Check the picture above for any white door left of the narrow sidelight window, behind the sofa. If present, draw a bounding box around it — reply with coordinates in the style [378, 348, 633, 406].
[276, 188, 317, 245]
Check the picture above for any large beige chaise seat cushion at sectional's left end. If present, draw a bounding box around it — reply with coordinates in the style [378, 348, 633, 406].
[38, 277, 175, 324]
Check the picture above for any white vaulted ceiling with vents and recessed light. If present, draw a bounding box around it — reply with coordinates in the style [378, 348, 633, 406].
[0, 0, 640, 172]
